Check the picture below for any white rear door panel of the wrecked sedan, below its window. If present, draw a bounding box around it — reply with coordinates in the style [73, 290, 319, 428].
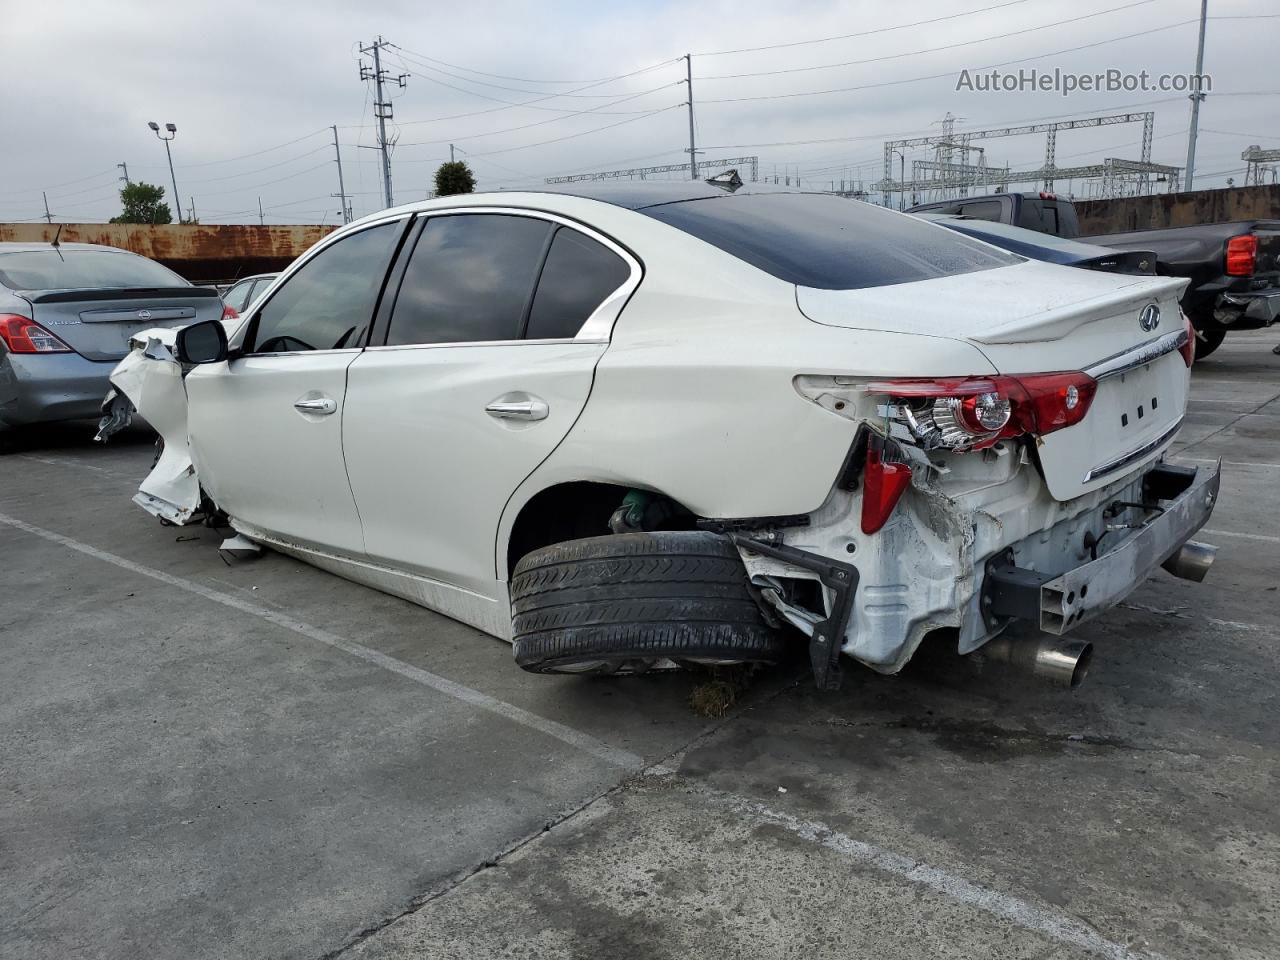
[343, 340, 606, 601]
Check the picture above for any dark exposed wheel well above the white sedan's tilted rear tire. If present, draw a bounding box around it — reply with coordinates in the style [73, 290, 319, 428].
[507, 480, 698, 577]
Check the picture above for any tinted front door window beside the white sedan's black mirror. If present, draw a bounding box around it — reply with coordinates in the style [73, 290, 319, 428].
[250, 221, 403, 353]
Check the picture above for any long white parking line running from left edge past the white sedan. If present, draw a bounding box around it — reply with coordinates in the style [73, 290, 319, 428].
[0, 513, 644, 771]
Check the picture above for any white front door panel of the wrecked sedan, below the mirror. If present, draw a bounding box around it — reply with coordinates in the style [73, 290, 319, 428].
[186, 351, 364, 554]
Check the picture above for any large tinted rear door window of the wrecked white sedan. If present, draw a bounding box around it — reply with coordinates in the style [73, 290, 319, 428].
[387, 214, 552, 346]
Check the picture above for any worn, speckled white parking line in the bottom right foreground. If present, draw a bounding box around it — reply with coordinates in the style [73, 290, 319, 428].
[696, 787, 1164, 960]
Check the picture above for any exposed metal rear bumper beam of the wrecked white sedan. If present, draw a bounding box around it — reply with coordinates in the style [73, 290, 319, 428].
[982, 463, 1221, 635]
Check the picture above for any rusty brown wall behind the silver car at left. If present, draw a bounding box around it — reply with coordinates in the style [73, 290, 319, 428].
[0, 223, 337, 283]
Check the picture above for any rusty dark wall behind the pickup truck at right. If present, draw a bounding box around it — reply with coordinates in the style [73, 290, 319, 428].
[1075, 184, 1280, 237]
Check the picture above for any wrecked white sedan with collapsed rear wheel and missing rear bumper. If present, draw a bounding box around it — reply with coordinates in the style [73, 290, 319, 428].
[99, 183, 1219, 686]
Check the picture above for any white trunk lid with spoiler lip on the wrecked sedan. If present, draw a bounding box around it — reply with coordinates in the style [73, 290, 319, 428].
[797, 261, 1190, 500]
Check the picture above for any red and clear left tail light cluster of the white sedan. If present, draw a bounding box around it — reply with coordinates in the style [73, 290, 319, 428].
[867, 371, 1098, 451]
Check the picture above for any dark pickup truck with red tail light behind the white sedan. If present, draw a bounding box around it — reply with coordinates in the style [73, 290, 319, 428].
[908, 193, 1280, 357]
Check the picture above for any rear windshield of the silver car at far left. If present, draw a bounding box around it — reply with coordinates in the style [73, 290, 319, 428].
[0, 247, 189, 291]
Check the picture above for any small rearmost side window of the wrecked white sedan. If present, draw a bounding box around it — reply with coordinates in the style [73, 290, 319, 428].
[525, 227, 631, 340]
